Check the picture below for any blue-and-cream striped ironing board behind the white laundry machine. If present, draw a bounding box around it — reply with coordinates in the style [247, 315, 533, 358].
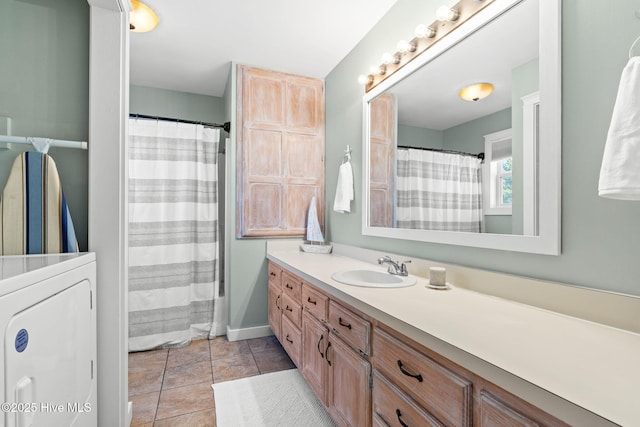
[0, 152, 78, 255]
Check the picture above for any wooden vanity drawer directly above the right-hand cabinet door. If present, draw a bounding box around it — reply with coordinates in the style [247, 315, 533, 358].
[329, 301, 371, 355]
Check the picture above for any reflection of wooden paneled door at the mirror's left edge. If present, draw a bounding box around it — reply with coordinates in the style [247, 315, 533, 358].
[369, 94, 396, 227]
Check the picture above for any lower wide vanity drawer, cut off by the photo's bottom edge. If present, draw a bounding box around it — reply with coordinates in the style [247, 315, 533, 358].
[373, 371, 444, 427]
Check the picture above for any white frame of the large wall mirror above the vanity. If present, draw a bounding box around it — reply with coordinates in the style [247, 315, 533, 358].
[362, 0, 562, 255]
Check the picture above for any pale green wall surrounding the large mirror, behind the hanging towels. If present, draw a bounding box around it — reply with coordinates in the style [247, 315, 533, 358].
[326, 0, 640, 295]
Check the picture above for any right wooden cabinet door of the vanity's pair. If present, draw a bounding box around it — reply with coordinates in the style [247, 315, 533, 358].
[325, 333, 371, 427]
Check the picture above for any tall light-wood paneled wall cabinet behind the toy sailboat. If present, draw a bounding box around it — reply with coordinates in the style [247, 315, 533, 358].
[237, 66, 324, 237]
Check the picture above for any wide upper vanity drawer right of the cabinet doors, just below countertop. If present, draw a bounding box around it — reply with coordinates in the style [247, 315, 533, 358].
[373, 328, 473, 426]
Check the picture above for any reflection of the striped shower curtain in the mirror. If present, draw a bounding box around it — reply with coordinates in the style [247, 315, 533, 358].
[396, 148, 482, 233]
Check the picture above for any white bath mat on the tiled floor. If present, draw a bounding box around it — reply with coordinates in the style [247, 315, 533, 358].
[212, 369, 335, 427]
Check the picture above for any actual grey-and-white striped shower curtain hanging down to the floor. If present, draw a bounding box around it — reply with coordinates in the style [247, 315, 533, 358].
[129, 119, 226, 351]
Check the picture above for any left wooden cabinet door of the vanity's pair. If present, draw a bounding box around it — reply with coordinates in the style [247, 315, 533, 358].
[302, 312, 329, 405]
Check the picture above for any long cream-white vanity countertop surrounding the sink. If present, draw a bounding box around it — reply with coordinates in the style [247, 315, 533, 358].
[268, 249, 640, 426]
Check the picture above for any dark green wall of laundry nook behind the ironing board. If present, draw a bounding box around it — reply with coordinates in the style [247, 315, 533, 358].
[0, 0, 89, 251]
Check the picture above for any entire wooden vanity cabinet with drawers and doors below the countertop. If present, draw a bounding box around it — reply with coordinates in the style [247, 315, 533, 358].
[269, 263, 568, 427]
